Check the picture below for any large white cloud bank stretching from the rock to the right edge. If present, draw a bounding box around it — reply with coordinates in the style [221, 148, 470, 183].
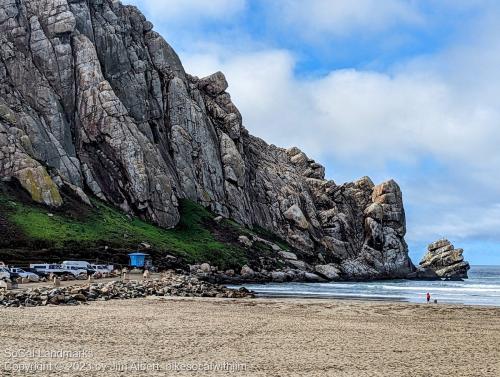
[184, 44, 500, 168]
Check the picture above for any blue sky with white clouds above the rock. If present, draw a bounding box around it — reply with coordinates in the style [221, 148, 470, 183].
[123, 0, 500, 265]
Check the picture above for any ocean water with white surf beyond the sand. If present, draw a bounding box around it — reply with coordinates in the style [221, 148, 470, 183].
[233, 266, 500, 306]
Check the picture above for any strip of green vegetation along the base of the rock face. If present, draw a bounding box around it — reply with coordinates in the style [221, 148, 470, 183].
[0, 188, 246, 268]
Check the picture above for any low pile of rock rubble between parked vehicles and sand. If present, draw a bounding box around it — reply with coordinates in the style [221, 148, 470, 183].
[0, 273, 253, 307]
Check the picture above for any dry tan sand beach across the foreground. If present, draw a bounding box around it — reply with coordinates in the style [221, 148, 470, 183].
[0, 298, 500, 377]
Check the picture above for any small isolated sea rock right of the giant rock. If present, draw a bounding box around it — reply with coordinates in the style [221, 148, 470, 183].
[420, 239, 470, 279]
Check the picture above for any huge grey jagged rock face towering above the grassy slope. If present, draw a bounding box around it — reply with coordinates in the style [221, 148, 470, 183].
[0, 0, 413, 279]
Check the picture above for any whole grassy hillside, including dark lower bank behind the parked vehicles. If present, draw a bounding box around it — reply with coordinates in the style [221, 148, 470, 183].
[0, 184, 252, 268]
